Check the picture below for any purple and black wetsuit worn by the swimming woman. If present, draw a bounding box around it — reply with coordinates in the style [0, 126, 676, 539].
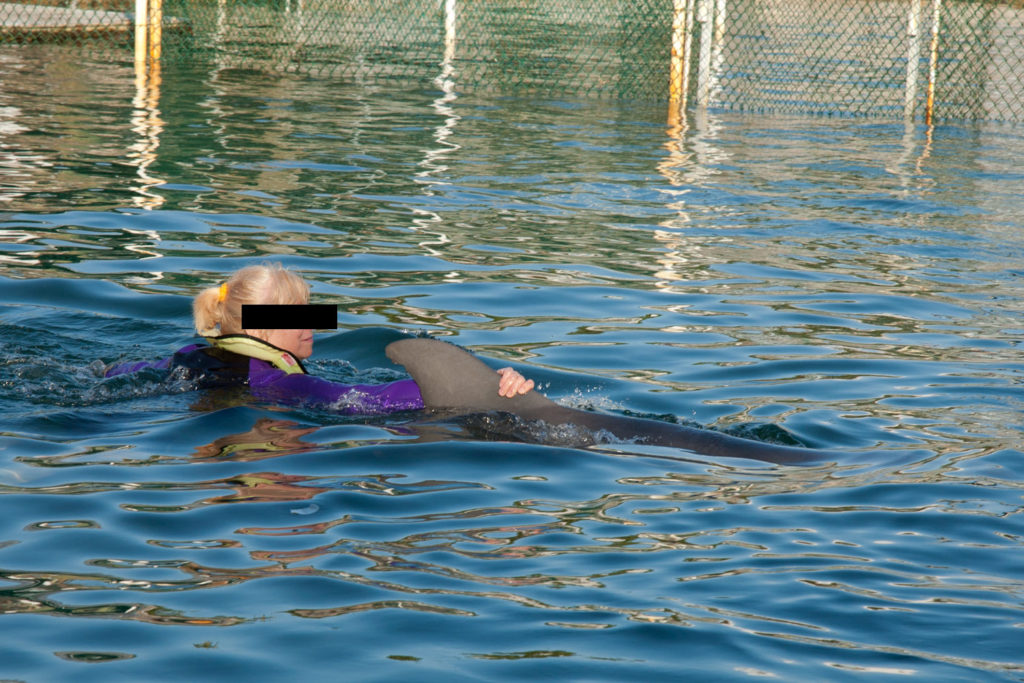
[104, 344, 423, 415]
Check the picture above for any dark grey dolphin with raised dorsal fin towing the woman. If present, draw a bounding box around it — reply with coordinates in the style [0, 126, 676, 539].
[385, 338, 824, 464]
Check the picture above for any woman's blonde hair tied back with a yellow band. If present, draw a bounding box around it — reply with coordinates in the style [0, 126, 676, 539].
[193, 263, 309, 337]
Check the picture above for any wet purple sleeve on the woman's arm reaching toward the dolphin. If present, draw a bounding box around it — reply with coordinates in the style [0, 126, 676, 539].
[249, 368, 423, 415]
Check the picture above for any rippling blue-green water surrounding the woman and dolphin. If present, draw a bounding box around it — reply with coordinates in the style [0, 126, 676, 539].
[0, 47, 1024, 681]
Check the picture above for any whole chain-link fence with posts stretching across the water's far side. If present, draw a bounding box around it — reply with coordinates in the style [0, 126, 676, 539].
[0, 0, 1024, 121]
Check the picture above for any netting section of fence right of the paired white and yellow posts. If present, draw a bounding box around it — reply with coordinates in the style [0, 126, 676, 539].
[712, 0, 1024, 120]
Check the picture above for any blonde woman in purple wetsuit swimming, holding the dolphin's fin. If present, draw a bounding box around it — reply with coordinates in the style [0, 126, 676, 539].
[104, 265, 534, 414]
